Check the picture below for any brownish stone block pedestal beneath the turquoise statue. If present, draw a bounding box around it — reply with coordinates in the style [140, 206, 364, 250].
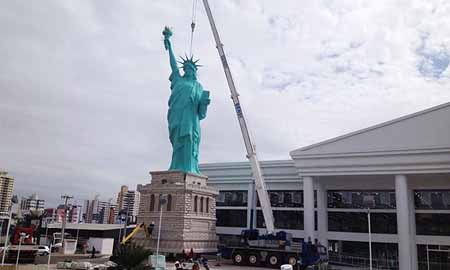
[134, 171, 218, 254]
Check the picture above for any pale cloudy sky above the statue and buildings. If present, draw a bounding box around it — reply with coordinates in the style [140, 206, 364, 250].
[0, 0, 450, 207]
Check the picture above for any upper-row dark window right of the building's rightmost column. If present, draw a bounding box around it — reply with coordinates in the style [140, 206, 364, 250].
[414, 190, 450, 209]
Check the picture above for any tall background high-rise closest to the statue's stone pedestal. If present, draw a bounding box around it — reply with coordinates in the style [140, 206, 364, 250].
[117, 186, 141, 223]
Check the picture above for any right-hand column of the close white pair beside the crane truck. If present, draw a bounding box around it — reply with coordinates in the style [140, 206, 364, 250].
[316, 181, 328, 249]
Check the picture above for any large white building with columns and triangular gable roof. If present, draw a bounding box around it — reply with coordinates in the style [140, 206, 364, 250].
[200, 103, 450, 270]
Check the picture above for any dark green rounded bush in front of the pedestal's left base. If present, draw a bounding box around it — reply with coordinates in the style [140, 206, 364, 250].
[110, 243, 152, 270]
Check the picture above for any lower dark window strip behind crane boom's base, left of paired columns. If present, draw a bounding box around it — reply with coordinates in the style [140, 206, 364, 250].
[256, 210, 303, 230]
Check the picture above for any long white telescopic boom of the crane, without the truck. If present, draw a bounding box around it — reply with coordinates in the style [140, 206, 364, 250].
[203, 0, 275, 234]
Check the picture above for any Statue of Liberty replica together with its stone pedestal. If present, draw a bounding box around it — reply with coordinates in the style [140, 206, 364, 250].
[134, 27, 219, 254]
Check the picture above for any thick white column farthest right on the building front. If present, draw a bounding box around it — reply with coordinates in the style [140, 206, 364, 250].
[395, 175, 417, 270]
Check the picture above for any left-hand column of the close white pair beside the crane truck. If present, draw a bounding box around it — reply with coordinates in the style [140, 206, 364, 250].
[303, 176, 314, 242]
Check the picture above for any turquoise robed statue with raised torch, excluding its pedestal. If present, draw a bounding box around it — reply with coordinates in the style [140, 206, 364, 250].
[163, 27, 210, 174]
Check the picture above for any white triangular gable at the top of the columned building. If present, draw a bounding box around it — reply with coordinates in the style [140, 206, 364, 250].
[290, 102, 450, 156]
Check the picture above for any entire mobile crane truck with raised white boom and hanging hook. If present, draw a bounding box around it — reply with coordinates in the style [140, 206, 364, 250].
[199, 0, 328, 268]
